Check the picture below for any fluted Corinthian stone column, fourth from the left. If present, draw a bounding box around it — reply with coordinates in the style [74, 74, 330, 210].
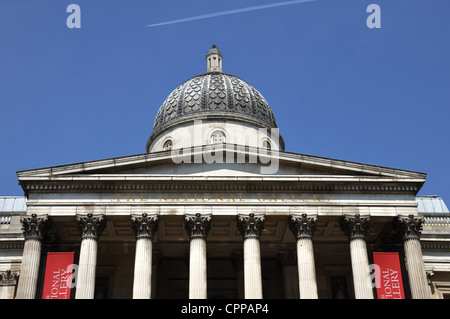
[184, 213, 211, 299]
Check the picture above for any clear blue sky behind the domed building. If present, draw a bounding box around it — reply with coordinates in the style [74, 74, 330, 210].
[0, 0, 450, 205]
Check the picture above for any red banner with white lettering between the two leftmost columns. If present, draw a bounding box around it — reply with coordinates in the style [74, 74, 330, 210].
[42, 252, 73, 299]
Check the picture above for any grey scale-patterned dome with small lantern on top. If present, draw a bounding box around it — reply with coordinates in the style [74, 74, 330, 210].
[149, 45, 277, 148]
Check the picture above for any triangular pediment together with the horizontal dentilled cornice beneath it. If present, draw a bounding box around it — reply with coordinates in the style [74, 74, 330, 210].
[17, 145, 426, 195]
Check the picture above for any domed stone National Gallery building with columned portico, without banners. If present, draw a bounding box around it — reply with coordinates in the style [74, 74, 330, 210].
[0, 46, 450, 299]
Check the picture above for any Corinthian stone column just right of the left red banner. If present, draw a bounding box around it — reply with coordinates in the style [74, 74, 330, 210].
[75, 214, 106, 299]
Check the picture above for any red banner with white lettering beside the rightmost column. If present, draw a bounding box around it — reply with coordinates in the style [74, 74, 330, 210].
[373, 253, 405, 299]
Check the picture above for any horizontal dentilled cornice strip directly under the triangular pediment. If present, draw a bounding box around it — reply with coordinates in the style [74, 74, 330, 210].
[17, 175, 421, 194]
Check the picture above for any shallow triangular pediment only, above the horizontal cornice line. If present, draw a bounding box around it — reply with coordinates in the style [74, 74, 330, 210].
[17, 147, 426, 179]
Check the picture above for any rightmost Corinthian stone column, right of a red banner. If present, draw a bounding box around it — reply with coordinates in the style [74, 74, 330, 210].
[394, 215, 431, 299]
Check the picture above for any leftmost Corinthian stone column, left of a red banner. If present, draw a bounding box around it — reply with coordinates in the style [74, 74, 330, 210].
[17, 214, 49, 299]
